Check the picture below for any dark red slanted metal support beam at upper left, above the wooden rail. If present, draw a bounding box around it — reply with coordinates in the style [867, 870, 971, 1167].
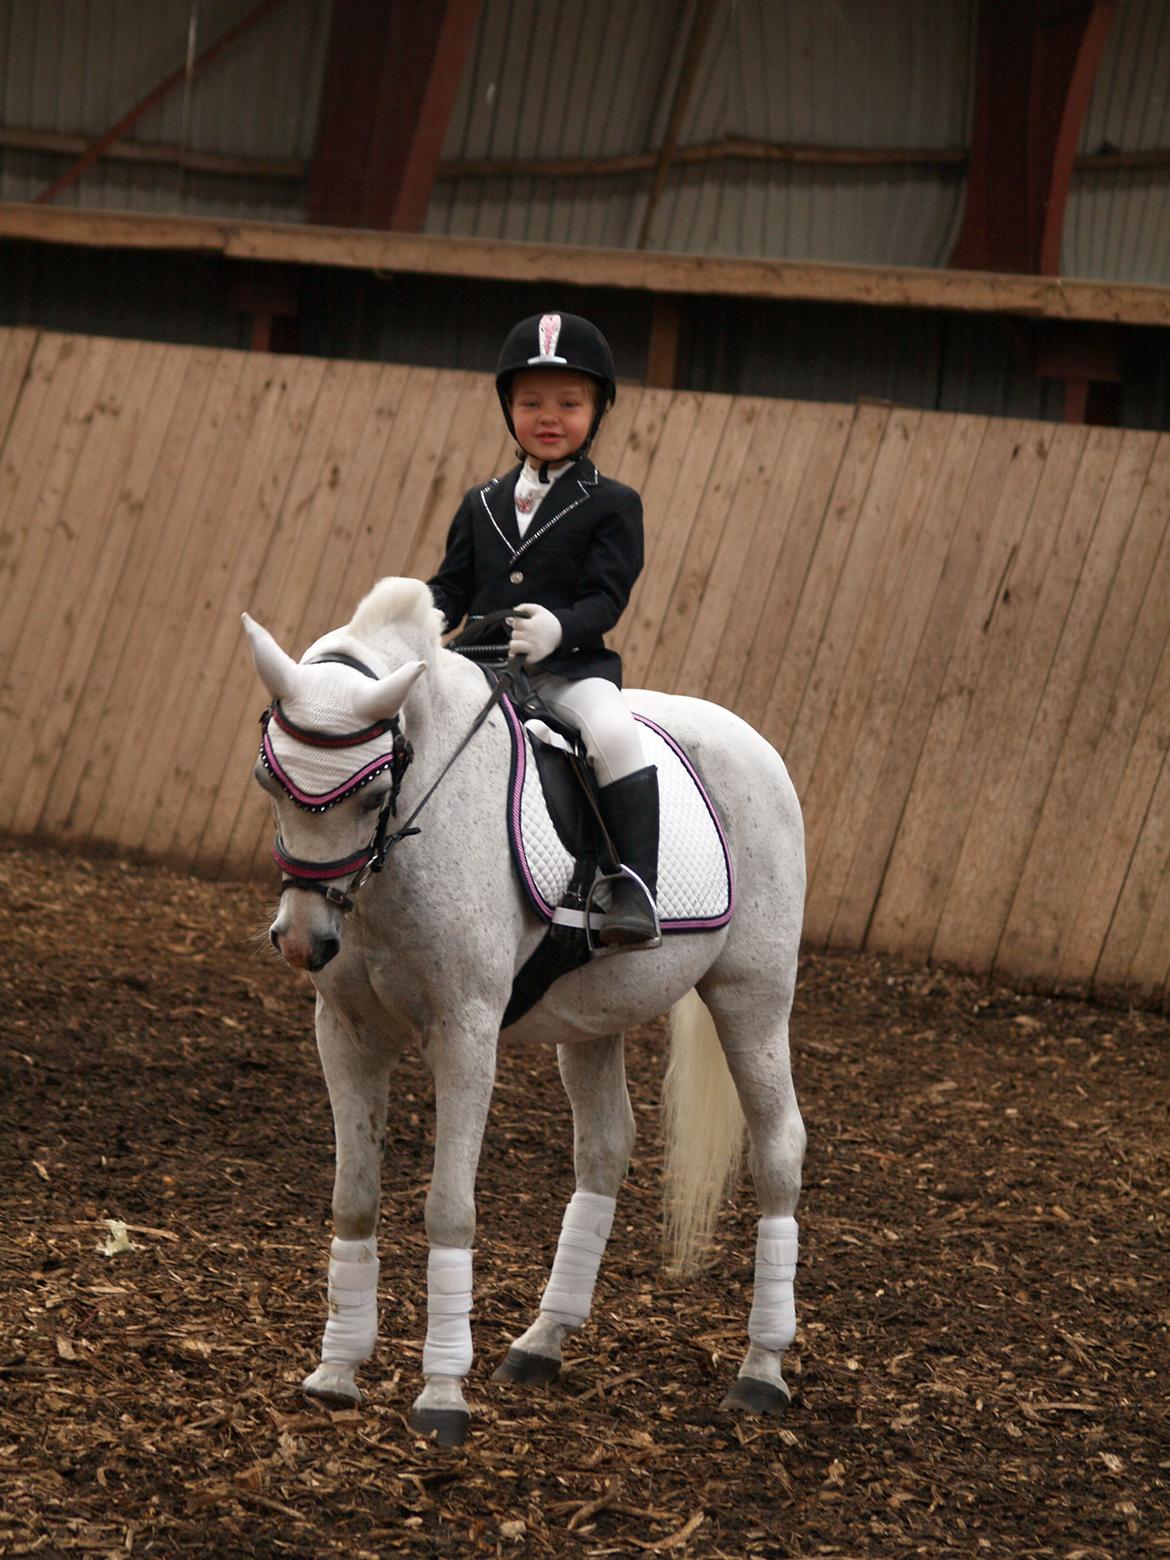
[307, 0, 480, 232]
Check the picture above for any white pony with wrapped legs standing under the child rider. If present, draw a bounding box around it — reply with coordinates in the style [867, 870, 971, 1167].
[245, 579, 805, 1445]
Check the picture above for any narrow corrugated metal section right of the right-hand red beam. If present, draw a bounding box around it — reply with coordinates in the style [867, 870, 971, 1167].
[1061, 0, 1170, 284]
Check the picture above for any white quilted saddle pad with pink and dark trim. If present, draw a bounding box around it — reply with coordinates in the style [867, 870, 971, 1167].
[507, 705, 735, 933]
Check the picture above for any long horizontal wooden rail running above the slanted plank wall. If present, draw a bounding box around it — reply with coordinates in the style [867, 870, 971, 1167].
[0, 204, 1170, 326]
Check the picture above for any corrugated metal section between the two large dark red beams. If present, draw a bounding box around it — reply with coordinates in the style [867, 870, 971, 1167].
[426, 0, 975, 265]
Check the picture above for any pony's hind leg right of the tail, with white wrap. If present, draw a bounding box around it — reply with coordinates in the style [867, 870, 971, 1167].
[704, 989, 805, 1413]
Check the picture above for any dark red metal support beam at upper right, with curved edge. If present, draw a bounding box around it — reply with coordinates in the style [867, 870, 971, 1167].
[950, 0, 1117, 276]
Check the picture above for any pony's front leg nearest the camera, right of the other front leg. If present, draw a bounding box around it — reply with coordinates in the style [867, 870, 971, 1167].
[410, 1014, 499, 1446]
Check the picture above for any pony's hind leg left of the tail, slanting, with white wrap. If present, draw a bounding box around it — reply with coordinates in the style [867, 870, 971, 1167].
[493, 1034, 633, 1382]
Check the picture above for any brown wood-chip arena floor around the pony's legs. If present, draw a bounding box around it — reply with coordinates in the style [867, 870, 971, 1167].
[0, 846, 1170, 1560]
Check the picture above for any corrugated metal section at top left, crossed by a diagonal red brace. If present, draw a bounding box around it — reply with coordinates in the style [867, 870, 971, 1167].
[0, 0, 329, 222]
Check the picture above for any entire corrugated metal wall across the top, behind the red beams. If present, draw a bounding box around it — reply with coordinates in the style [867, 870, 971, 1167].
[0, 0, 1170, 293]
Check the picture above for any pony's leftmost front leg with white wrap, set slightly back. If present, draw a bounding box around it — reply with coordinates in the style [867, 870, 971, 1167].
[303, 994, 395, 1409]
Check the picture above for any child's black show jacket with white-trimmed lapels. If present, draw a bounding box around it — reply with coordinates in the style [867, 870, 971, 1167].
[429, 460, 643, 688]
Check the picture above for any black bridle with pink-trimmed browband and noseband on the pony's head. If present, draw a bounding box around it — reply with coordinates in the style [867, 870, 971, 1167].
[261, 652, 512, 911]
